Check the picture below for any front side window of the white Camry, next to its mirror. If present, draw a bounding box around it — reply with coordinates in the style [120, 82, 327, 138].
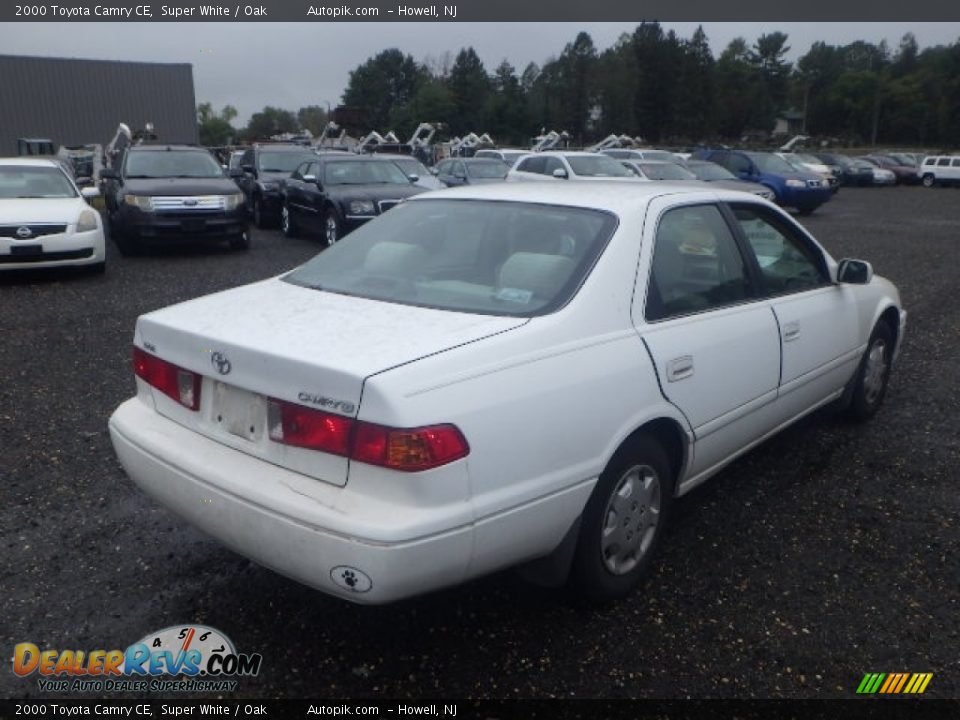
[732, 205, 829, 295]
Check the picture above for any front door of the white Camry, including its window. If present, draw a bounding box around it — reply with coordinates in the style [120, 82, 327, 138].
[730, 203, 862, 419]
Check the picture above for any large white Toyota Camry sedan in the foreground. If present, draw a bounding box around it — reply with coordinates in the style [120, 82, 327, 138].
[110, 183, 906, 603]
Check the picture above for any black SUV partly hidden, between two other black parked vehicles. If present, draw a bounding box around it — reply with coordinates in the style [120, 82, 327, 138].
[237, 143, 317, 228]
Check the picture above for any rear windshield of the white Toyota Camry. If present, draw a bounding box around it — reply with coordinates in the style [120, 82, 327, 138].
[284, 199, 617, 317]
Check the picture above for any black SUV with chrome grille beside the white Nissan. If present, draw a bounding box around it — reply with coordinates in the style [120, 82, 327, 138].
[101, 145, 250, 255]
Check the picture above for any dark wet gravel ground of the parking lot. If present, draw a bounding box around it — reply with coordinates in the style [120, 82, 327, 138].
[0, 187, 960, 699]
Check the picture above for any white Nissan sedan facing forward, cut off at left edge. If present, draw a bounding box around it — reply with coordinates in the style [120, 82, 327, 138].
[0, 158, 106, 272]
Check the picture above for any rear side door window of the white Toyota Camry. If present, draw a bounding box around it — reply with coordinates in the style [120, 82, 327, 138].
[645, 205, 751, 320]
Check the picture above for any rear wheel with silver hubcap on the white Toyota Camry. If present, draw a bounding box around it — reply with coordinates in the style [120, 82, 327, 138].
[570, 435, 674, 601]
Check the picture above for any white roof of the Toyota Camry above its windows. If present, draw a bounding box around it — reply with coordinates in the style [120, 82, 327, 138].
[407, 180, 757, 215]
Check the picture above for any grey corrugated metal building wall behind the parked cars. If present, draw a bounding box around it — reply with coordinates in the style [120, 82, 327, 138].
[0, 55, 199, 156]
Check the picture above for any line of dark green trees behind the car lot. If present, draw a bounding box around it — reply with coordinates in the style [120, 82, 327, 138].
[198, 22, 960, 147]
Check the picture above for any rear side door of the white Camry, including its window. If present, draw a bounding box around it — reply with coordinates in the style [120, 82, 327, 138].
[633, 197, 780, 477]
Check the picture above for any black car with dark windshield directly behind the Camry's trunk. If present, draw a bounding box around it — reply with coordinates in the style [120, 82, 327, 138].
[280, 153, 425, 245]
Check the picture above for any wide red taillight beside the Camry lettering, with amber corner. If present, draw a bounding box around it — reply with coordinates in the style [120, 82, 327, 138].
[267, 398, 470, 472]
